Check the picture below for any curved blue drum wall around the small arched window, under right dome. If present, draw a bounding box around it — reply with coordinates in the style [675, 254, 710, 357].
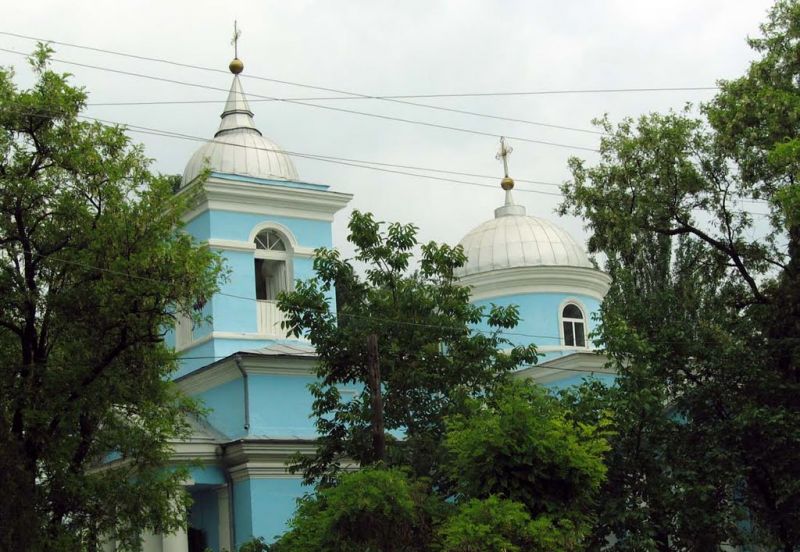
[468, 293, 600, 347]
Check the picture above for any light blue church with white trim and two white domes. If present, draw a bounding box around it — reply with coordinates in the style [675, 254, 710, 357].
[107, 60, 613, 552]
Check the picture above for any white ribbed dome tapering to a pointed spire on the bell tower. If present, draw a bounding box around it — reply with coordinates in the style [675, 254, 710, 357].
[182, 75, 298, 185]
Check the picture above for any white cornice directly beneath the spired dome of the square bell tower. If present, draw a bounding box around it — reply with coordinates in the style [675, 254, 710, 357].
[184, 176, 353, 221]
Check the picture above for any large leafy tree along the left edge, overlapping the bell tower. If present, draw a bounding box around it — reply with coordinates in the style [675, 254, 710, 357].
[0, 45, 221, 551]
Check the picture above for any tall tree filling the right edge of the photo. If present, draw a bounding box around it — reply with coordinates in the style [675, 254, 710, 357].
[562, 1, 800, 551]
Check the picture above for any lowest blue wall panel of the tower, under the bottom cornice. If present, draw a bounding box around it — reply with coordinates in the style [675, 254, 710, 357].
[234, 477, 308, 547]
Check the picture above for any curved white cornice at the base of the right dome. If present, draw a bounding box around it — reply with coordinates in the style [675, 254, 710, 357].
[460, 266, 611, 301]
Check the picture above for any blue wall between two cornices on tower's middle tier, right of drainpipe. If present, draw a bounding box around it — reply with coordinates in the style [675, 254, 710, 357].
[248, 374, 317, 438]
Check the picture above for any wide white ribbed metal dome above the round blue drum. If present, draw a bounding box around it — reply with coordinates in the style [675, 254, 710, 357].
[457, 194, 594, 277]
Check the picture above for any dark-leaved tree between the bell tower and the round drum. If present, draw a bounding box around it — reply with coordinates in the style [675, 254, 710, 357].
[279, 211, 536, 484]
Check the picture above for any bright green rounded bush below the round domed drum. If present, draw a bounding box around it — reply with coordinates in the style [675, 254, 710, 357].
[446, 380, 608, 542]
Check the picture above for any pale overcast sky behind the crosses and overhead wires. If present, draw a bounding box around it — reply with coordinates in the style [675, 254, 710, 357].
[0, 0, 771, 258]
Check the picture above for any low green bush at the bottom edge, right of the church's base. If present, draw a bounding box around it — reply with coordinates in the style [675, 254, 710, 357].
[273, 468, 444, 552]
